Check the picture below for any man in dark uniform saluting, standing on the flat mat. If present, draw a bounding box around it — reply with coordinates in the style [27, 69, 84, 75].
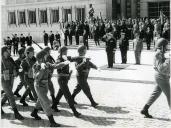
[102, 32, 116, 68]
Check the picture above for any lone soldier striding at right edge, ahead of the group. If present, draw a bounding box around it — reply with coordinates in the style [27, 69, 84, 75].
[141, 38, 171, 118]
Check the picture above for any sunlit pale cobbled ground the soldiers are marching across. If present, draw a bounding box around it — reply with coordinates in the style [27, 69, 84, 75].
[1, 43, 171, 128]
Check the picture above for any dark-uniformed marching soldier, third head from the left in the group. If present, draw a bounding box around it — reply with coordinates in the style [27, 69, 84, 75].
[20, 46, 37, 106]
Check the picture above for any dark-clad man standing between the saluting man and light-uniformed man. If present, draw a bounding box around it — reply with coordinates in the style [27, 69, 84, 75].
[119, 32, 129, 64]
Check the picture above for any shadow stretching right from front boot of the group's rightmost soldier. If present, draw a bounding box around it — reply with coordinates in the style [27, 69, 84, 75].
[96, 106, 129, 114]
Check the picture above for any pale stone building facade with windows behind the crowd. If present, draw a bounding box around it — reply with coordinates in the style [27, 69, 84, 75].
[1, 0, 170, 42]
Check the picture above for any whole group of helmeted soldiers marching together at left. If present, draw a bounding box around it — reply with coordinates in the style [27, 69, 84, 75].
[1, 43, 101, 127]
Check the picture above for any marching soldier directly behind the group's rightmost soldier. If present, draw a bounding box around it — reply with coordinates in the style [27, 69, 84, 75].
[52, 46, 81, 117]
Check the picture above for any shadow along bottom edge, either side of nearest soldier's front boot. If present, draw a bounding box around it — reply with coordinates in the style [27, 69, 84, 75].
[10, 117, 75, 127]
